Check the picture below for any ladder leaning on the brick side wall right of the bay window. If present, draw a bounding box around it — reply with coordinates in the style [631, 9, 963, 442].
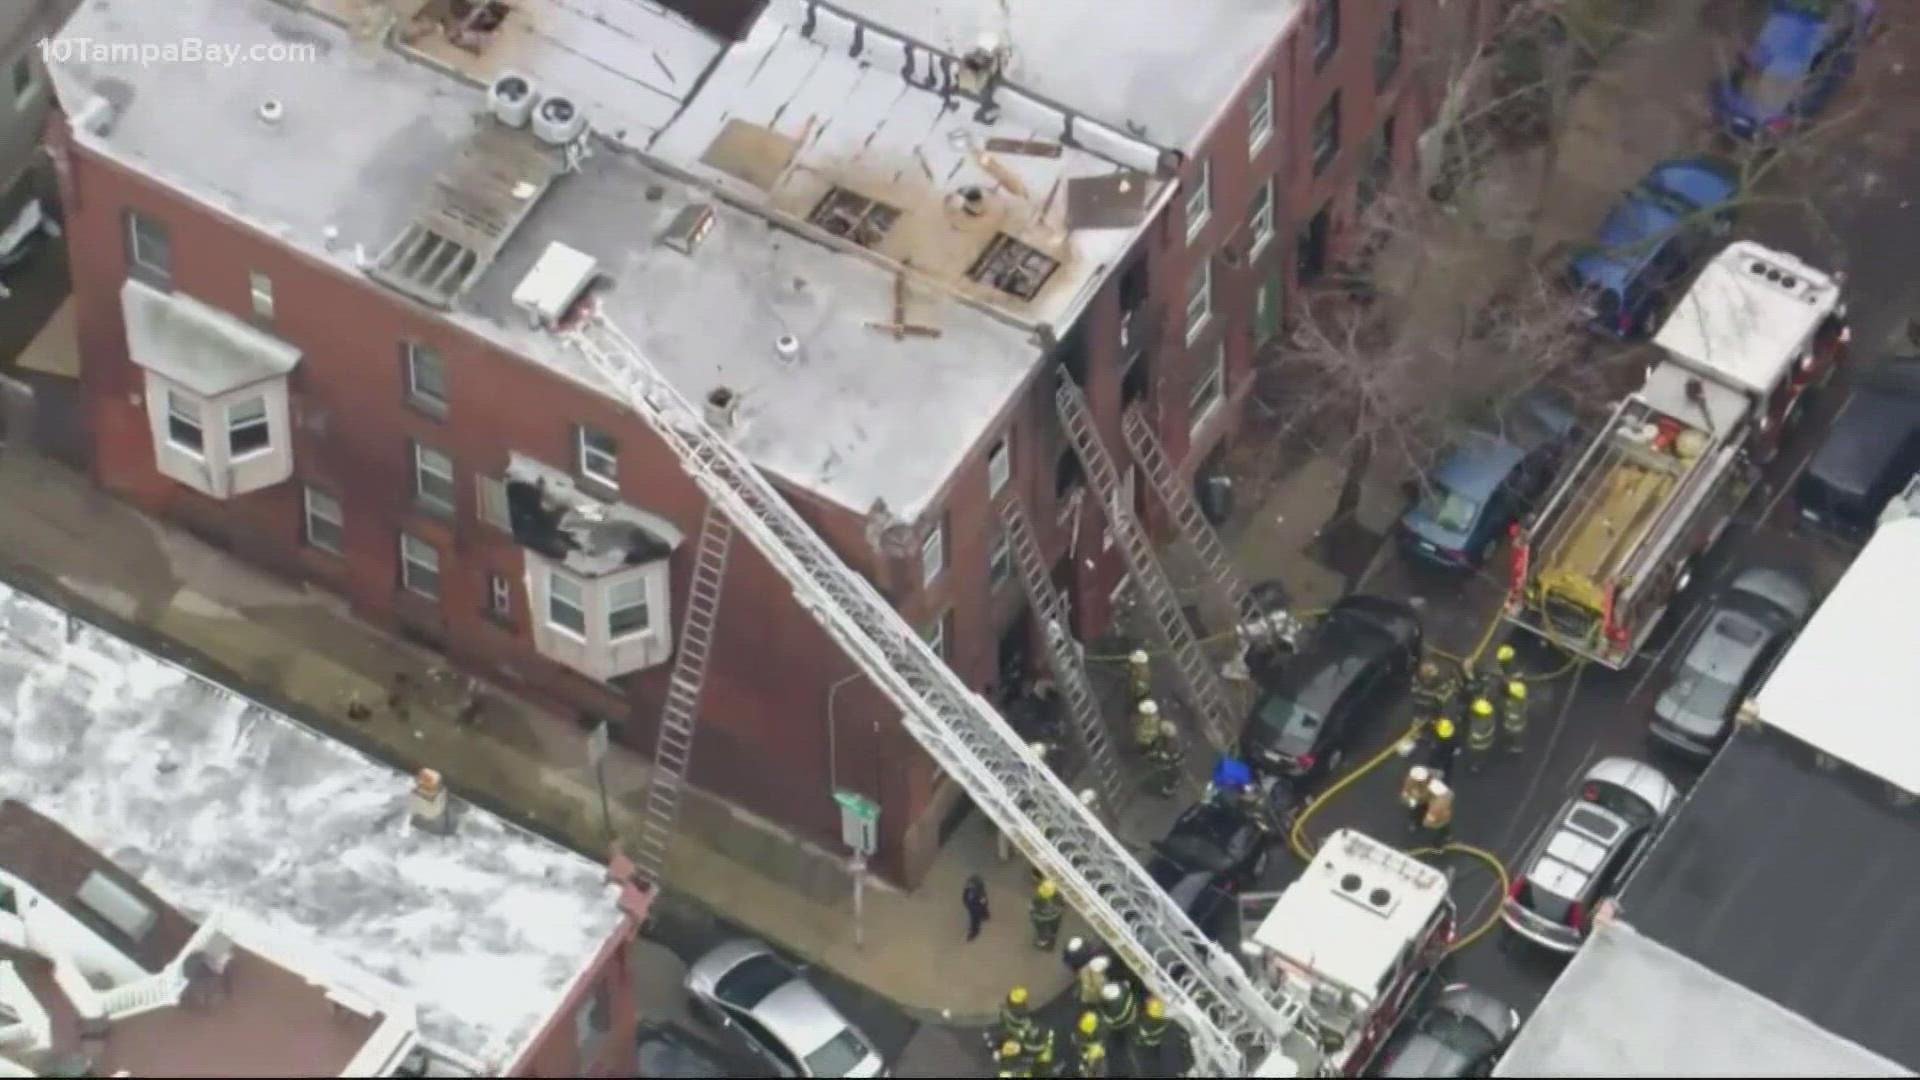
[634, 503, 733, 888]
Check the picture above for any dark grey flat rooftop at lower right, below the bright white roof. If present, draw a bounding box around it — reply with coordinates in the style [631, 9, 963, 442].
[1620, 722, 1920, 1072]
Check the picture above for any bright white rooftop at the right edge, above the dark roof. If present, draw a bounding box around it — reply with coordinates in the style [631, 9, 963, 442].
[1757, 519, 1920, 794]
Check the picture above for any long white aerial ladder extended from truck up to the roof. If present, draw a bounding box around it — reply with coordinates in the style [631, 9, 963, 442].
[559, 298, 1313, 1076]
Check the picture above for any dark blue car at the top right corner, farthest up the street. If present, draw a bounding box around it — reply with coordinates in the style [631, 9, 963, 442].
[1713, 0, 1874, 140]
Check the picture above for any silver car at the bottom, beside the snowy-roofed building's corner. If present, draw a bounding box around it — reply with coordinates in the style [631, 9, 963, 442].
[685, 938, 887, 1076]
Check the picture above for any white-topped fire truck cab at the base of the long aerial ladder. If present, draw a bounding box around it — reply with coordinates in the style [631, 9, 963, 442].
[1244, 828, 1455, 1076]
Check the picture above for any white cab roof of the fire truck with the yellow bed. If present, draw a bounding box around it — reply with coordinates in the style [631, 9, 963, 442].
[1653, 240, 1839, 394]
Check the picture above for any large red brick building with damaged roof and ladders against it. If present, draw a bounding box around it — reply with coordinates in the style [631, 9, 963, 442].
[52, 0, 1466, 882]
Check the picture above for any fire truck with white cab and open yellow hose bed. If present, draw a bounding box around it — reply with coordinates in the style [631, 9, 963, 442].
[1505, 240, 1849, 671]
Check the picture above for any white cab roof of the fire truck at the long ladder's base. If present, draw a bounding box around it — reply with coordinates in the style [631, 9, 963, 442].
[1254, 828, 1448, 995]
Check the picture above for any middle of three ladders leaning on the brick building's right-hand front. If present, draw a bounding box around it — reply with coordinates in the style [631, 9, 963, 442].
[1054, 379, 1235, 753]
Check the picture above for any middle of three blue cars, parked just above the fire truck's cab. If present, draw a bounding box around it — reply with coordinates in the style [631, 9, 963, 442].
[1567, 158, 1740, 340]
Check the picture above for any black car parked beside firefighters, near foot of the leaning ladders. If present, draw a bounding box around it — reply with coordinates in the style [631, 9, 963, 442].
[1240, 596, 1421, 788]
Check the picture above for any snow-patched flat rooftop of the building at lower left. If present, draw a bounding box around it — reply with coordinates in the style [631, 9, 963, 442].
[0, 586, 622, 1070]
